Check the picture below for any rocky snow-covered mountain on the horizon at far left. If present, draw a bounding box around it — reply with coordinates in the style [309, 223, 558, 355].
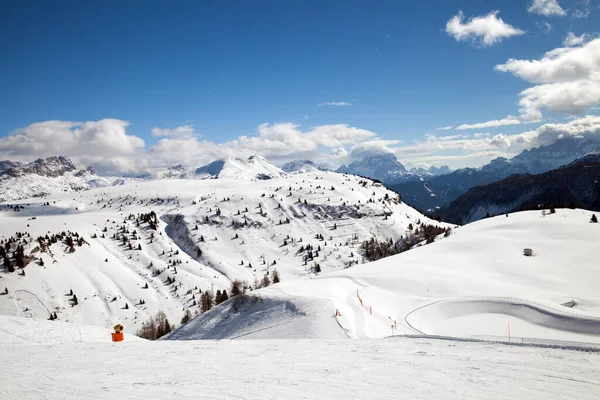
[0, 156, 114, 202]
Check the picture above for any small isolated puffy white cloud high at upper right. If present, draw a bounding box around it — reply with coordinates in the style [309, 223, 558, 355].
[446, 11, 525, 46]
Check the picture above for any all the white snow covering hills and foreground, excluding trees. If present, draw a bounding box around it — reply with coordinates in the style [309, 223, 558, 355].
[0, 172, 600, 400]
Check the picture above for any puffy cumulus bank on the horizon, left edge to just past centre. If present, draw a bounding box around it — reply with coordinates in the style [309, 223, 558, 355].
[0, 119, 380, 174]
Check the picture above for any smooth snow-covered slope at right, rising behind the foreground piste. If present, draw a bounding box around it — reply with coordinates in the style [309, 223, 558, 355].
[170, 210, 600, 343]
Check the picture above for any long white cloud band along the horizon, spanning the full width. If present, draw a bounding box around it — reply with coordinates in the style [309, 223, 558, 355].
[0, 115, 600, 174]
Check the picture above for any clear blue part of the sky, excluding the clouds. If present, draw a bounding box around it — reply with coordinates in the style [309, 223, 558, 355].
[0, 0, 600, 173]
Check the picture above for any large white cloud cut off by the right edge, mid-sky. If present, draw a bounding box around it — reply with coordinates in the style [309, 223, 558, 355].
[495, 39, 600, 120]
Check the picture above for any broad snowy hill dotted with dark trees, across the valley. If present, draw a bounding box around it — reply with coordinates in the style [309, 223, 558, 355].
[0, 172, 446, 329]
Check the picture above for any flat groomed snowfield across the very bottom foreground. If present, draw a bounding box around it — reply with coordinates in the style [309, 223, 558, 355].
[0, 338, 600, 400]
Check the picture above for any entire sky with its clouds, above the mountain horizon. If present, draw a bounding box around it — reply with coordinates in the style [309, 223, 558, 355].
[0, 0, 600, 174]
